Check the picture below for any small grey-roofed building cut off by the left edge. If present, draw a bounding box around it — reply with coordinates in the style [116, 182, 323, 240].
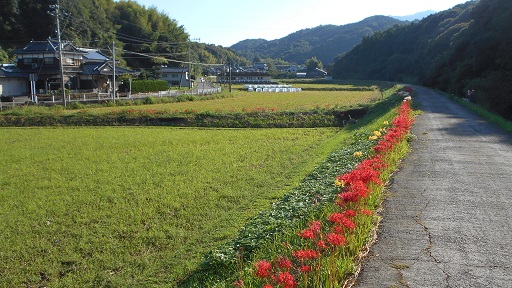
[0, 64, 29, 96]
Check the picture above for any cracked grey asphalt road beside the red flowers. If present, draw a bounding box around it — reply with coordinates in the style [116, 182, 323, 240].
[353, 87, 512, 287]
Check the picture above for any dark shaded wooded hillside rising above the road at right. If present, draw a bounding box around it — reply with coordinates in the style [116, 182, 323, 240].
[332, 0, 512, 119]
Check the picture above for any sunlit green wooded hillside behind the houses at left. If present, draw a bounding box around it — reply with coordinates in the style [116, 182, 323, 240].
[0, 0, 246, 69]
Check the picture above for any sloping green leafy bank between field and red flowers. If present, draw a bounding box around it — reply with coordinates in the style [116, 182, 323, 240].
[180, 93, 408, 287]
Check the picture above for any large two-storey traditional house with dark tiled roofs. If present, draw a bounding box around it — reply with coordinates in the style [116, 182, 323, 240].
[14, 39, 136, 94]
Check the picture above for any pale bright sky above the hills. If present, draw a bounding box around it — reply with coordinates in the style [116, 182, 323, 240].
[130, 0, 468, 47]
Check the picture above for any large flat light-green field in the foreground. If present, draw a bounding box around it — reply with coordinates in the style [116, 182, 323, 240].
[0, 128, 346, 287]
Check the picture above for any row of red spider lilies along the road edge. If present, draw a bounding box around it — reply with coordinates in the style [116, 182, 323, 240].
[241, 99, 413, 288]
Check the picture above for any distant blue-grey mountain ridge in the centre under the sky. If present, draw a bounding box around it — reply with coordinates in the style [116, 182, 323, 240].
[230, 16, 408, 65]
